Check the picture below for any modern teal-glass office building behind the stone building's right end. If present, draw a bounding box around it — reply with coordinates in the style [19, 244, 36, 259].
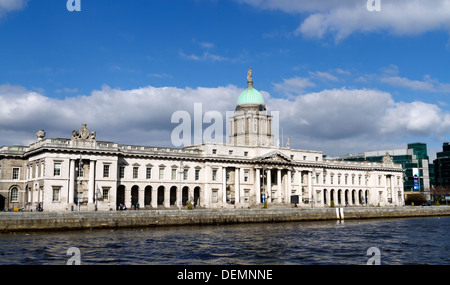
[334, 142, 434, 197]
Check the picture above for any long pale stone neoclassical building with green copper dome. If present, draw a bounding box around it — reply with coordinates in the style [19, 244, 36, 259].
[0, 70, 404, 211]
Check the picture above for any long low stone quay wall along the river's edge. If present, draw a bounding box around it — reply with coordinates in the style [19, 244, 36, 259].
[0, 206, 450, 233]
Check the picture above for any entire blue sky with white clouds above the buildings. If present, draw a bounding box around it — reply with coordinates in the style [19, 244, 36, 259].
[0, 0, 450, 157]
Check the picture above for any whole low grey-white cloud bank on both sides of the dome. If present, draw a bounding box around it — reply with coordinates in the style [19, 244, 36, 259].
[0, 82, 450, 155]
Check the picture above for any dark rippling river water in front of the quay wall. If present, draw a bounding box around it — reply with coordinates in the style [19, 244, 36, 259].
[0, 217, 450, 265]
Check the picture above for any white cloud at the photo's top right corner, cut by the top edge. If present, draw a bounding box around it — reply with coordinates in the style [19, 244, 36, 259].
[239, 0, 450, 41]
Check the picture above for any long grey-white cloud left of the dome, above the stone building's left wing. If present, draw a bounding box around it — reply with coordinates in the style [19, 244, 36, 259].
[0, 85, 242, 146]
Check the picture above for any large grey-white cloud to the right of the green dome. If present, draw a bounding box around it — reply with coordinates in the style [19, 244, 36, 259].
[266, 88, 450, 155]
